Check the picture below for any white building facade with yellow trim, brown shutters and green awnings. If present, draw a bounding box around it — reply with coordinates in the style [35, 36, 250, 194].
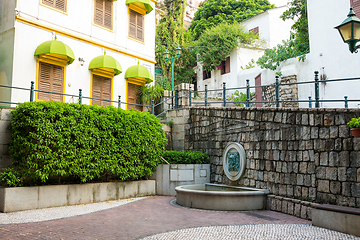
[0, 0, 155, 108]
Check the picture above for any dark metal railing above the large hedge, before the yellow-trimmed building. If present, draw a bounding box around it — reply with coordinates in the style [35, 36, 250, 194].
[0, 81, 178, 116]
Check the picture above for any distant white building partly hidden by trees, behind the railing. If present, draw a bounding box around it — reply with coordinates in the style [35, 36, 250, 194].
[196, 6, 294, 94]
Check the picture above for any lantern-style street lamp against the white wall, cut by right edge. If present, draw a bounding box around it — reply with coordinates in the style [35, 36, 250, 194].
[335, 8, 360, 53]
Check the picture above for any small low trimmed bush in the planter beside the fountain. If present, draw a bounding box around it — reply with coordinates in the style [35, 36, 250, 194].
[162, 151, 210, 164]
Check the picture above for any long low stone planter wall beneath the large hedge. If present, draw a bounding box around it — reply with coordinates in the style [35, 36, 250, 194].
[0, 180, 155, 212]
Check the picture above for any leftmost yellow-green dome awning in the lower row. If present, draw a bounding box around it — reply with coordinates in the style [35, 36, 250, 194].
[34, 40, 75, 64]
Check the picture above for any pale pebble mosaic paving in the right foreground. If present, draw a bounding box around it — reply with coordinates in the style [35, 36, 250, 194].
[143, 224, 360, 240]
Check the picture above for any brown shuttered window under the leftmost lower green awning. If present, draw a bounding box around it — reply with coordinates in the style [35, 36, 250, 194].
[38, 62, 64, 102]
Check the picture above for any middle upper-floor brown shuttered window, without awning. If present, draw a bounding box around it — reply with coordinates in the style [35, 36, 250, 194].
[94, 0, 113, 30]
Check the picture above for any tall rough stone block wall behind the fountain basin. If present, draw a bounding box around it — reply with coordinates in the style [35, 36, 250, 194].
[181, 107, 360, 214]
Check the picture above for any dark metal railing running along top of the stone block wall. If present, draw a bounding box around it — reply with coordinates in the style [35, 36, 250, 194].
[189, 71, 360, 108]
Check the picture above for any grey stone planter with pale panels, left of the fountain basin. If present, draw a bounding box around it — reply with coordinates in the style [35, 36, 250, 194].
[153, 164, 210, 196]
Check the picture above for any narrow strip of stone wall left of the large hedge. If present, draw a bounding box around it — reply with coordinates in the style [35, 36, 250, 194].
[0, 108, 11, 170]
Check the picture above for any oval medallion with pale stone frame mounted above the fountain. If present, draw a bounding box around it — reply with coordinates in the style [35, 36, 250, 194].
[223, 142, 246, 181]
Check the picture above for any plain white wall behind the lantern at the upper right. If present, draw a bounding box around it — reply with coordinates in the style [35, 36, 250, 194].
[307, 0, 360, 107]
